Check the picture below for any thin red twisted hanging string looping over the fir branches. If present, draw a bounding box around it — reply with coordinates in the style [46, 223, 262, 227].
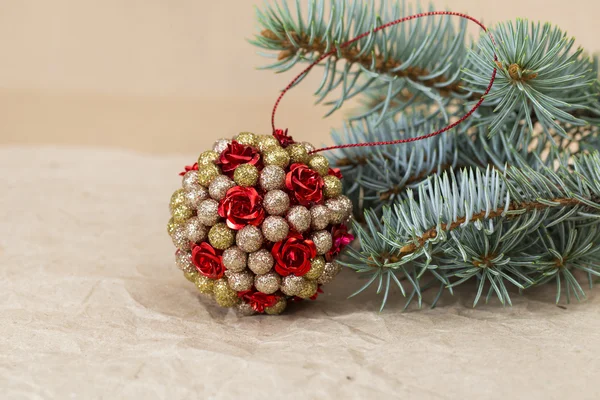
[271, 11, 498, 154]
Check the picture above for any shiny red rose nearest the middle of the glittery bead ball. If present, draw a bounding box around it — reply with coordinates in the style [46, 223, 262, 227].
[219, 186, 265, 231]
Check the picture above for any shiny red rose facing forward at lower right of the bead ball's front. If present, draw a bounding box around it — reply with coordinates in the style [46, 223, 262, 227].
[271, 233, 317, 276]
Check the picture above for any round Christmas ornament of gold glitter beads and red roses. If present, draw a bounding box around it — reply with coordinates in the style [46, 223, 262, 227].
[167, 131, 352, 316]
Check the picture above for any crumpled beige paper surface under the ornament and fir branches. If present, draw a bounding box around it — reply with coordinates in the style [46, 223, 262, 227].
[0, 147, 600, 399]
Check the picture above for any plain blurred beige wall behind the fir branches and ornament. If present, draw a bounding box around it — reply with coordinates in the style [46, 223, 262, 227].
[0, 0, 600, 153]
